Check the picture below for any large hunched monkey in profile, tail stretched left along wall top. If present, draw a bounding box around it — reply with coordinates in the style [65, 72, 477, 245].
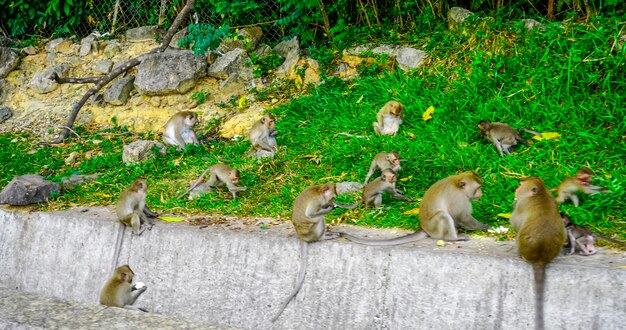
[340, 171, 490, 246]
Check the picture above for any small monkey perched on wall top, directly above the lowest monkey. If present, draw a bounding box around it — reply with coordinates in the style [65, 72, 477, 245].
[115, 178, 159, 235]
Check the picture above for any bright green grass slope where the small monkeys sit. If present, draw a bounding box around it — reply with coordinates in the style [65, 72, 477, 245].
[0, 17, 626, 240]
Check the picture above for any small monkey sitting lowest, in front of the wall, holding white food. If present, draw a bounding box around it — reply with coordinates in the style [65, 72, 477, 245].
[100, 265, 148, 312]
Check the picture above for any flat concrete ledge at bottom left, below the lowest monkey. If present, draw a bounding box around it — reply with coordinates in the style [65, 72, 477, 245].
[0, 288, 233, 330]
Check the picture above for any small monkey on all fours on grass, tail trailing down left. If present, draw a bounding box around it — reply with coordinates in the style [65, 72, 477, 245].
[176, 164, 248, 200]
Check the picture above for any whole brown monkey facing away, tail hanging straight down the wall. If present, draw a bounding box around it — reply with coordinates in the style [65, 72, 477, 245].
[510, 176, 565, 330]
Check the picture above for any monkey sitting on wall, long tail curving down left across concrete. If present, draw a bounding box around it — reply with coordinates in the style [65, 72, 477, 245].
[272, 183, 350, 322]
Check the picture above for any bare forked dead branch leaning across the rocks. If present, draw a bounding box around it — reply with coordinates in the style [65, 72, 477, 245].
[43, 0, 196, 144]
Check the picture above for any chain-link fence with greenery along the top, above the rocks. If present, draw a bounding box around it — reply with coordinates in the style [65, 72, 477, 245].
[59, 0, 284, 41]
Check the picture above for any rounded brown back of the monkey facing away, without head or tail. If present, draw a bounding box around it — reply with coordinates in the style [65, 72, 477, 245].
[516, 196, 565, 263]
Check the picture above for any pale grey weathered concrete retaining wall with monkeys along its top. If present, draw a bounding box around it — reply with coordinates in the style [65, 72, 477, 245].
[0, 208, 626, 330]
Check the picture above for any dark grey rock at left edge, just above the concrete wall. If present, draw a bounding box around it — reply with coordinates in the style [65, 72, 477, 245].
[0, 174, 61, 205]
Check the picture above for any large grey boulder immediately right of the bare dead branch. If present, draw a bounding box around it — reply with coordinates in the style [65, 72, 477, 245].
[135, 50, 206, 95]
